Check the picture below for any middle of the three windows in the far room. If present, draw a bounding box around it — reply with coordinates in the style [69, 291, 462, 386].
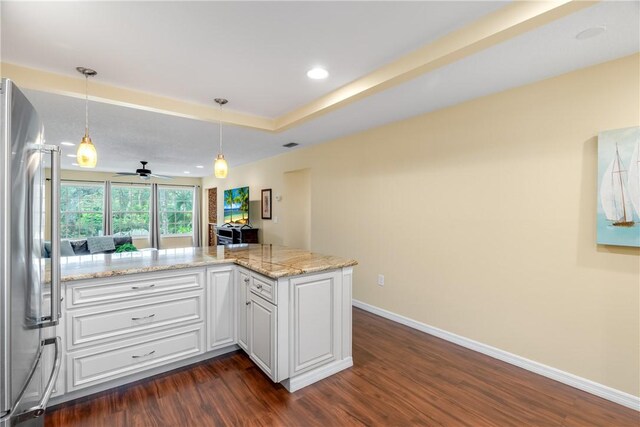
[111, 184, 151, 236]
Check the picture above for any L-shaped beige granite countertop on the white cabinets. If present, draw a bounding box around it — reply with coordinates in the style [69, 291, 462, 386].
[52, 244, 357, 282]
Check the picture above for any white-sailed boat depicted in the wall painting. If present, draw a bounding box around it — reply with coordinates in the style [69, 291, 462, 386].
[600, 144, 634, 227]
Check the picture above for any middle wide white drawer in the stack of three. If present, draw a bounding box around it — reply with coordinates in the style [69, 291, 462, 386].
[65, 291, 204, 350]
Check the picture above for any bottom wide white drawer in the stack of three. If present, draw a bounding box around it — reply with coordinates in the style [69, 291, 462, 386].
[67, 325, 203, 391]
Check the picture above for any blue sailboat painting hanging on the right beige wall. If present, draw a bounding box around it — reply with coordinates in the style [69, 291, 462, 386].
[597, 127, 640, 247]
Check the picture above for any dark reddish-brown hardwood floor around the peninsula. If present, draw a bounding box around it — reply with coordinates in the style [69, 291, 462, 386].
[46, 309, 640, 427]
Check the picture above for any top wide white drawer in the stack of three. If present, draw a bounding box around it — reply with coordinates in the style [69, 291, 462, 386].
[67, 270, 204, 308]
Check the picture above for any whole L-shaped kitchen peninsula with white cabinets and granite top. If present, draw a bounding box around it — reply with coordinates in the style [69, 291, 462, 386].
[45, 244, 356, 404]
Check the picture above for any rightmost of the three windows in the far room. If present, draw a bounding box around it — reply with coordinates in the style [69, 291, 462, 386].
[158, 187, 193, 236]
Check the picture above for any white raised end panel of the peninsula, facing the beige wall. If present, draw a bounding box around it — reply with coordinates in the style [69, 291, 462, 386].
[290, 271, 342, 376]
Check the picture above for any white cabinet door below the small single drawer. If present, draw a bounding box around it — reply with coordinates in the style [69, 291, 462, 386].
[249, 293, 277, 381]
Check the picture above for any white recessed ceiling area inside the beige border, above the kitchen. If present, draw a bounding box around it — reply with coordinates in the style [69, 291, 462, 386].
[2, 1, 506, 117]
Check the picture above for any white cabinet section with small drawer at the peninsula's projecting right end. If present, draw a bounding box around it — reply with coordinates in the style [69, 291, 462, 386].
[236, 269, 353, 391]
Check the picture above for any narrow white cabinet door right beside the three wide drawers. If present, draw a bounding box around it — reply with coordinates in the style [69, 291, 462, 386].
[207, 266, 235, 350]
